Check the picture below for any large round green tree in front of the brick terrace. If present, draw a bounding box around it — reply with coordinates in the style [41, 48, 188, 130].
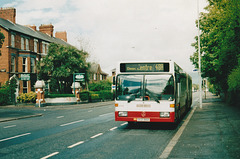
[38, 43, 89, 93]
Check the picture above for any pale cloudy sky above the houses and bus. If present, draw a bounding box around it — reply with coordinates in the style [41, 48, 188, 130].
[0, 0, 208, 83]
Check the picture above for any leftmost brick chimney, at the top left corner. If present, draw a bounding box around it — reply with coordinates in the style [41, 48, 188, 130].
[0, 8, 16, 24]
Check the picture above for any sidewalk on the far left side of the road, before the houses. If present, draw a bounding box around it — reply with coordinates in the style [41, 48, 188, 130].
[0, 101, 114, 122]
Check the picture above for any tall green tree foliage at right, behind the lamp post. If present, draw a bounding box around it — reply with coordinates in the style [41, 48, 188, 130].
[190, 0, 240, 99]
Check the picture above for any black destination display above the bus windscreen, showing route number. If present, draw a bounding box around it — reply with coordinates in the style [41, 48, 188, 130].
[120, 63, 169, 72]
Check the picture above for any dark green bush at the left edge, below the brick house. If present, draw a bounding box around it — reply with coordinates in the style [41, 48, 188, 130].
[0, 79, 16, 105]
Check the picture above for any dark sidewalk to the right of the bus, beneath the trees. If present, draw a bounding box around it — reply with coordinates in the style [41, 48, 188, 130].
[168, 94, 240, 159]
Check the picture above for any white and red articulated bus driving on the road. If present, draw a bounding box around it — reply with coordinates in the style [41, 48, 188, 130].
[115, 61, 192, 124]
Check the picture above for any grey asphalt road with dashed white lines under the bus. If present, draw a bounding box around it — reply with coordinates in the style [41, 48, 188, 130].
[0, 93, 201, 159]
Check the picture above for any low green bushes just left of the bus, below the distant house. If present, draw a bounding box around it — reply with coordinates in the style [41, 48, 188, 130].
[88, 80, 112, 91]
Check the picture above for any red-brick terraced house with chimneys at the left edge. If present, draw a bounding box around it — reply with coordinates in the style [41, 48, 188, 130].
[0, 8, 70, 93]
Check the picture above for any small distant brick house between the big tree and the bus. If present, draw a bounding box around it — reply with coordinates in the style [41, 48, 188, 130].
[89, 63, 108, 83]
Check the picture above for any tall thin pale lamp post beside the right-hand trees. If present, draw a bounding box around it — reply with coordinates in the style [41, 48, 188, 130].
[197, 0, 202, 109]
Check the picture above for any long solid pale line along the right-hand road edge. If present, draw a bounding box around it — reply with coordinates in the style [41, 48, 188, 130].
[159, 107, 197, 159]
